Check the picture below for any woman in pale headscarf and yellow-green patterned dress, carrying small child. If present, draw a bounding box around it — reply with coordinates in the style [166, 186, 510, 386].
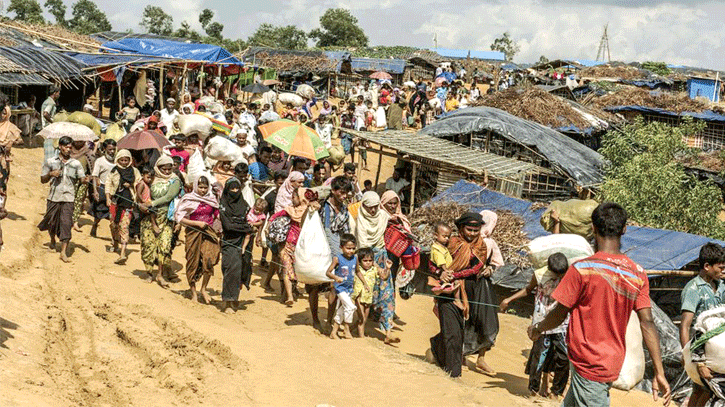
[139, 155, 182, 288]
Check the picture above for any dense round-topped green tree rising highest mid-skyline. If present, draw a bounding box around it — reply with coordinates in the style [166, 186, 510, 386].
[310, 8, 368, 48]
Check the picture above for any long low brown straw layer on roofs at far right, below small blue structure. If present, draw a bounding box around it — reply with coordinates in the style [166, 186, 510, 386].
[590, 87, 725, 113]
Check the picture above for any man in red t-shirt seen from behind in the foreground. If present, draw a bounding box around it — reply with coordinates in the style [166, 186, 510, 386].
[529, 202, 671, 407]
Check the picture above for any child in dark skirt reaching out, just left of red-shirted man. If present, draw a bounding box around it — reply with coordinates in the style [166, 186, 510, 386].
[500, 253, 569, 400]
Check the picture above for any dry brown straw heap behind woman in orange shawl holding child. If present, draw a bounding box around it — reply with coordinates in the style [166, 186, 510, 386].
[410, 202, 531, 268]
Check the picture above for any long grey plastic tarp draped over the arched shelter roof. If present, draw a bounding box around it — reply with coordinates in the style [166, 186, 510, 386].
[420, 106, 604, 186]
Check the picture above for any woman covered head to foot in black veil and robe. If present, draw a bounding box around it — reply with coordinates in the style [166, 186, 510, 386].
[219, 178, 253, 312]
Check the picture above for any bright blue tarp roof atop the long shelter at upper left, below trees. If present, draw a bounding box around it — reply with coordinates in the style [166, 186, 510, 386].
[103, 38, 243, 65]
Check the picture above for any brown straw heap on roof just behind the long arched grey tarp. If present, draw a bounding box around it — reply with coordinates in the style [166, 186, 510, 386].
[471, 86, 592, 129]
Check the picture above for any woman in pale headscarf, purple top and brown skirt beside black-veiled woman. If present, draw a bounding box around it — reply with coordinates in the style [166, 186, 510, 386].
[174, 175, 222, 304]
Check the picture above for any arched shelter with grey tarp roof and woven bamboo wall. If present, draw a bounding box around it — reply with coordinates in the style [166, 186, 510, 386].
[419, 107, 604, 200]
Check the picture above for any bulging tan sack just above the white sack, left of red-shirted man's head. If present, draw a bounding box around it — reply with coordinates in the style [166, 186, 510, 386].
[540, 199, 599, 239]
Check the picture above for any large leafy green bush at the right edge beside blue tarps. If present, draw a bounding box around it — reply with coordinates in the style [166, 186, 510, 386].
[600, 119, 725, 239]
